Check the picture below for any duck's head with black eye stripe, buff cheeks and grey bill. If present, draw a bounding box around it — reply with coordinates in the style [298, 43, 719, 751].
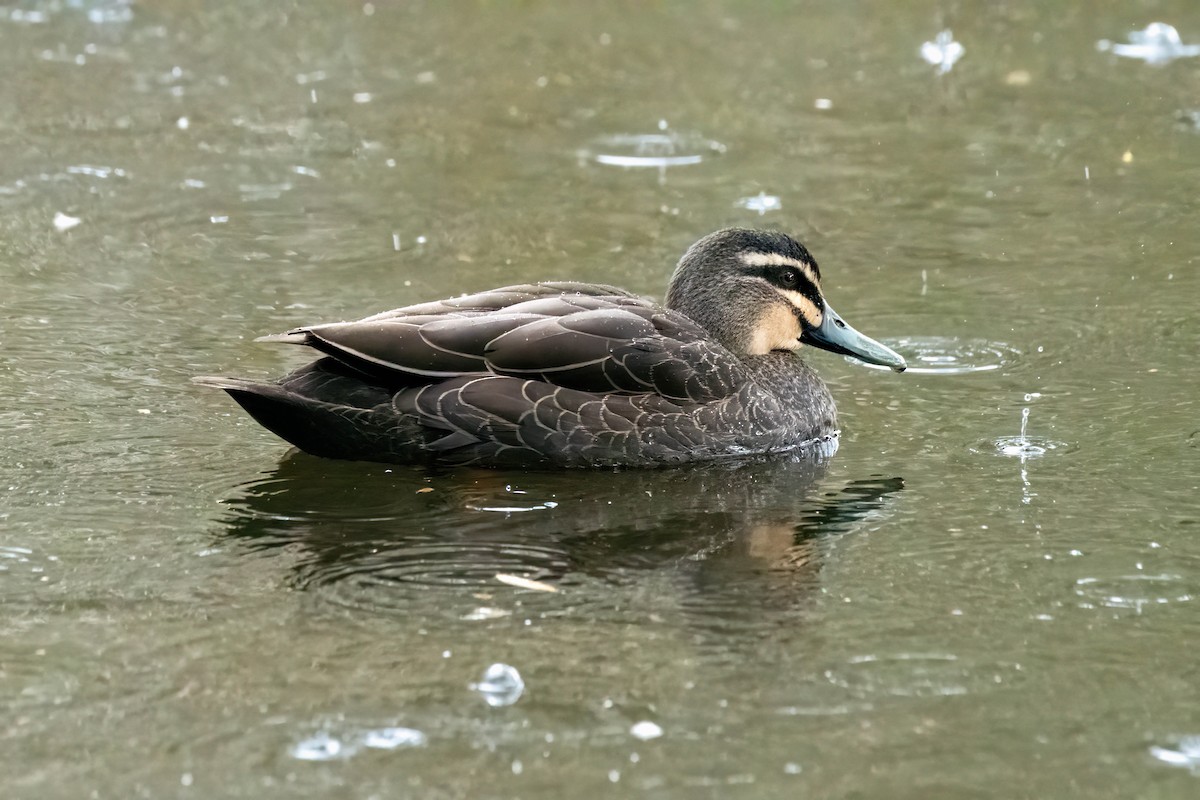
[667, 228, 906, 372]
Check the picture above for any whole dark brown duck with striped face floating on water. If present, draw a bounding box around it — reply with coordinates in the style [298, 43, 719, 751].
[193, 228, 906, 468]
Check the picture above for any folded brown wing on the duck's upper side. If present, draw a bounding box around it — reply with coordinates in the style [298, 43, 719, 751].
[263, 283, 745, 403]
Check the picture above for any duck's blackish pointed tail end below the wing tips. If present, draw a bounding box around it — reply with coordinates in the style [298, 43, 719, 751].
[192, 359, 426, 463]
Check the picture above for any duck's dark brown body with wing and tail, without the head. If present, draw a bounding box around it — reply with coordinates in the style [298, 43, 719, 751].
[200, 283, 835, 467]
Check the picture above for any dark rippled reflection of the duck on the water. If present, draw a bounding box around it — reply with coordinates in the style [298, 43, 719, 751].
[216, 453, 902, 625]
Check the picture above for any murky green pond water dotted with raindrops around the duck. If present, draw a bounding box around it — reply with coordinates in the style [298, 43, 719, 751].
[0, 1, 1200, 798]
